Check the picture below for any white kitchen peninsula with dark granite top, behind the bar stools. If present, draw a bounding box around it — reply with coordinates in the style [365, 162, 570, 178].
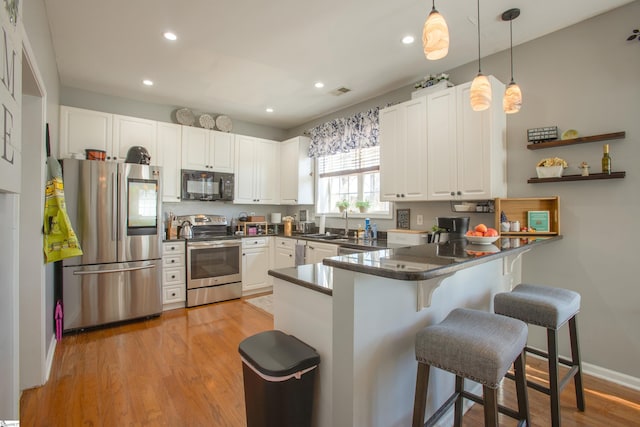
[269, 236, 561, 427]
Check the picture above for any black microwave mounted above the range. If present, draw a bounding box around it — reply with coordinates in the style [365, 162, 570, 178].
[182, 169, 233, 201]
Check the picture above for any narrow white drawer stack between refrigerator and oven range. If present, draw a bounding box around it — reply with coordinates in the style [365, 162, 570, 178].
[162, 241, 187, 311]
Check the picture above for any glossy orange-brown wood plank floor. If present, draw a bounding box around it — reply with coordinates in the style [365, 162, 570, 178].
[20, 300, 640, 427]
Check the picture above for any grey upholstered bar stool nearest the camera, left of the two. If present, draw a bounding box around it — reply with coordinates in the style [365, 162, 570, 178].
[413, 308, 529, 427]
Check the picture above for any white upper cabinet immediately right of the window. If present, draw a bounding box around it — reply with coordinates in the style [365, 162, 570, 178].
[379, 97, 427, 201]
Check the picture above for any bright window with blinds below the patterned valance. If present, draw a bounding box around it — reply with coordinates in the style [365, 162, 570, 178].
[316, 146, 391, 217]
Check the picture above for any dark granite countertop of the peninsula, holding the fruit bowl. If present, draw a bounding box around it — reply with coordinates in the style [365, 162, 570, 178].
[269, 236, 562, 294]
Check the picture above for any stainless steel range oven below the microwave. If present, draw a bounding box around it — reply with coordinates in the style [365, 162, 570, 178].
[178, 215, 242, 307]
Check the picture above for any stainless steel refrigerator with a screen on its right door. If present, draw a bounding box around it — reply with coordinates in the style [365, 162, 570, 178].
[62, 159, 163, 331]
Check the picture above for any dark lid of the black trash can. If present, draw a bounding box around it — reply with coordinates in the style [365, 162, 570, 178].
[238, 330, 320, 377]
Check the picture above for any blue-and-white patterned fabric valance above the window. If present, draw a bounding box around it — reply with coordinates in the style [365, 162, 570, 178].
[305, 107, 380, 157]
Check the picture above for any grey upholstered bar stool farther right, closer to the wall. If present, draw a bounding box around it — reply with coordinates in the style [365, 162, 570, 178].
[494, 283, 585, 427]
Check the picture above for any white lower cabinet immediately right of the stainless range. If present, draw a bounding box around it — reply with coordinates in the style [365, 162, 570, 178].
[242, 237, 271, 295]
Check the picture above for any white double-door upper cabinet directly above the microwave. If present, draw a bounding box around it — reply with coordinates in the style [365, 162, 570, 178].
[182, 126, 235, 173]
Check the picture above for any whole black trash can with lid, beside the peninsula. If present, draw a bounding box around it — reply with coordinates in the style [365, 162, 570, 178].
[238, 331, 320, 427]
